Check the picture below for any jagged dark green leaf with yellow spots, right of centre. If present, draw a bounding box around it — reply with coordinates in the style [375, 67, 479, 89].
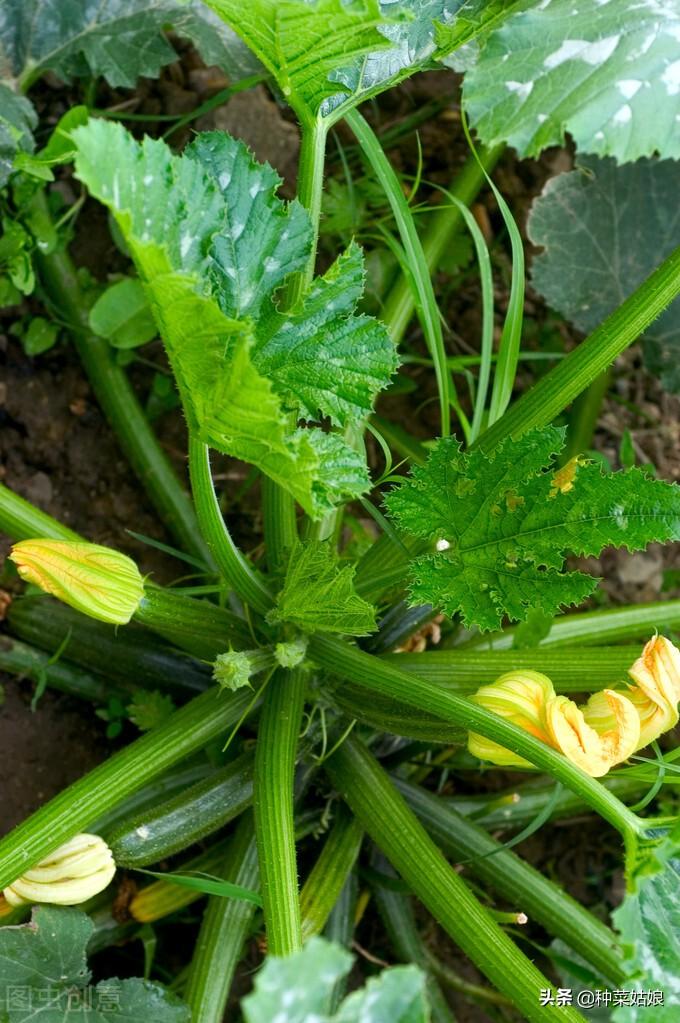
[386, 427, 680, 630]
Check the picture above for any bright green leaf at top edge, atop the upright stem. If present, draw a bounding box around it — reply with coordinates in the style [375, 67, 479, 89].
[206, 0, 484, 122]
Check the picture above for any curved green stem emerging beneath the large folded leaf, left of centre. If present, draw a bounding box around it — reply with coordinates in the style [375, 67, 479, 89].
[189, 436, 274, 614]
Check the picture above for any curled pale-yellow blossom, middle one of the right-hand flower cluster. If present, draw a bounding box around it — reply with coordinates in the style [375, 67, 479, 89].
[545, 690, 640, 777]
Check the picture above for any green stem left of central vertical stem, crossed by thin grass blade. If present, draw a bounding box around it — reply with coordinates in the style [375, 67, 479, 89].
[184, 812, 260, 1023]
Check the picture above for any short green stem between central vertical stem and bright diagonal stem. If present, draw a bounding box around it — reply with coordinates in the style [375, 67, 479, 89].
[300, 807, 364, 941]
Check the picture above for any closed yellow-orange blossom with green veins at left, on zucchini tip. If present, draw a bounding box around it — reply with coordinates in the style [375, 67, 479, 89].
[9, 540, 144, 625]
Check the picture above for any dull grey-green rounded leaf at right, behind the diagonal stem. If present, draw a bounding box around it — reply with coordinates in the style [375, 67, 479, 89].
[528, 157, 680, 391]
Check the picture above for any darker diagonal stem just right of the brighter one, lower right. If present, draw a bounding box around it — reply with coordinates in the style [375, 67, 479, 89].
[393, 779, 625, 986]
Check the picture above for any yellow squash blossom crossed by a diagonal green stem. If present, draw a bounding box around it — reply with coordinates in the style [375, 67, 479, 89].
[467, 671, 555, 767]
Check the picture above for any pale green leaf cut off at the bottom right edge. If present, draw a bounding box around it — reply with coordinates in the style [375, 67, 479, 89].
[613, 859, 680, 1023]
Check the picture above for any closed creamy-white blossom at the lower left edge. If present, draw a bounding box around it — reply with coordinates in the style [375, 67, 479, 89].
[2, 835, 116, 906]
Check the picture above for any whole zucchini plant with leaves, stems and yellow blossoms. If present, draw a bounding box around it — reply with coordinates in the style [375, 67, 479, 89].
[0, 0, 680, 1023]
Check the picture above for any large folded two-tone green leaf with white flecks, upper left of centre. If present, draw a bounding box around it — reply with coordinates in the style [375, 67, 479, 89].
[74, 121, 397, 517]
